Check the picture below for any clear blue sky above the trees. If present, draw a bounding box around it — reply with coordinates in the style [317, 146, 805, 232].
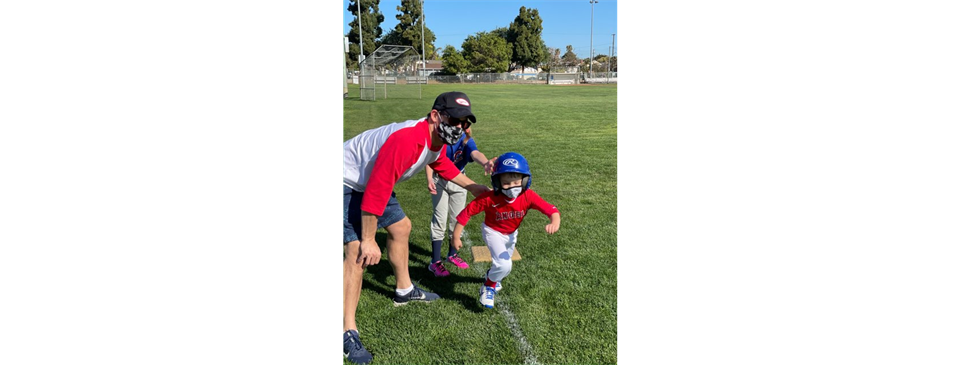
[341, 0, 620, 58]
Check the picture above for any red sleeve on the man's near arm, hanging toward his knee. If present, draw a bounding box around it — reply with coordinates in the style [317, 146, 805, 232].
[360, 134, 422, 217]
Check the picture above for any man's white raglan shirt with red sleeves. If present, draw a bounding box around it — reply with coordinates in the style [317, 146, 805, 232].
[343, 118, 460, 216]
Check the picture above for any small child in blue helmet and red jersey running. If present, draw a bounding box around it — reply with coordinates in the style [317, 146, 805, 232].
[451, 152, 560, 308]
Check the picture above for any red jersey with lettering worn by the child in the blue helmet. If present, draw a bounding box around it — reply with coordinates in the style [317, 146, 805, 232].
[457, 189, 560, 234]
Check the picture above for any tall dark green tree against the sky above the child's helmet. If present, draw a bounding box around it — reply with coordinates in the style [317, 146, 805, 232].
[507, 6, 549, 67]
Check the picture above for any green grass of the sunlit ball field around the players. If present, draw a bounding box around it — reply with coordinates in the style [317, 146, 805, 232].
[343, 85, 619, 364]
